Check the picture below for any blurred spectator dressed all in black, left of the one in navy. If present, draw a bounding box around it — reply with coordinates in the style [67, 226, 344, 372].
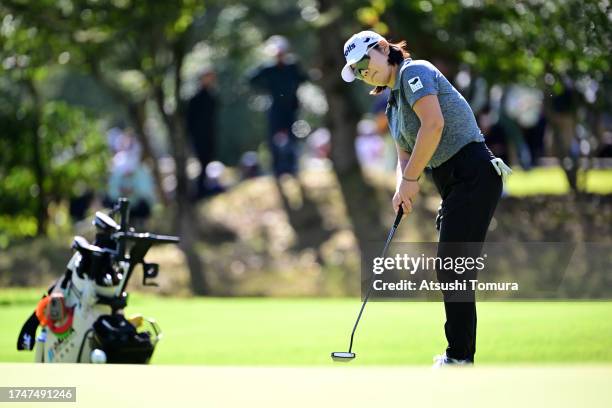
[187, 70, 217, 197]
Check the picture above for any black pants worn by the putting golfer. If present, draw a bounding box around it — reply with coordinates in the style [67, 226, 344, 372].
[432, 142, 502, 361]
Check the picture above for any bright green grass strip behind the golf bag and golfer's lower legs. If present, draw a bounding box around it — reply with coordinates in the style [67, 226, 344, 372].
[0, 289, 612, 366]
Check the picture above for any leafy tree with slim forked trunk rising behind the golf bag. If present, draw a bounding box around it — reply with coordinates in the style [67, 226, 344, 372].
[4, 0, 209, 294]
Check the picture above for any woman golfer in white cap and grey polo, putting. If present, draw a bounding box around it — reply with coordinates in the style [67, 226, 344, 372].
[342, 31, 512, 366]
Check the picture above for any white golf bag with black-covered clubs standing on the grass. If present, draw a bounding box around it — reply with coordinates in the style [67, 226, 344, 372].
[17, 198, 179, 364]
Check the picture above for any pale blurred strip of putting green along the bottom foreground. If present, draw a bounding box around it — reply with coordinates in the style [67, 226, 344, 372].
[0, 364, 612, 408]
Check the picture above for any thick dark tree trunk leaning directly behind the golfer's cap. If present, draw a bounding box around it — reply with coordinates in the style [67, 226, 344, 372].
[318, 1, 385, 252]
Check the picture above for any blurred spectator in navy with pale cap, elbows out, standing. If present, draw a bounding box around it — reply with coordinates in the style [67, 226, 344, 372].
[249, 35, 308, 177]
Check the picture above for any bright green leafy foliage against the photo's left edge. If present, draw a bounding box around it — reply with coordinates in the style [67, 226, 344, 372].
[0, 8, 107, 242]
